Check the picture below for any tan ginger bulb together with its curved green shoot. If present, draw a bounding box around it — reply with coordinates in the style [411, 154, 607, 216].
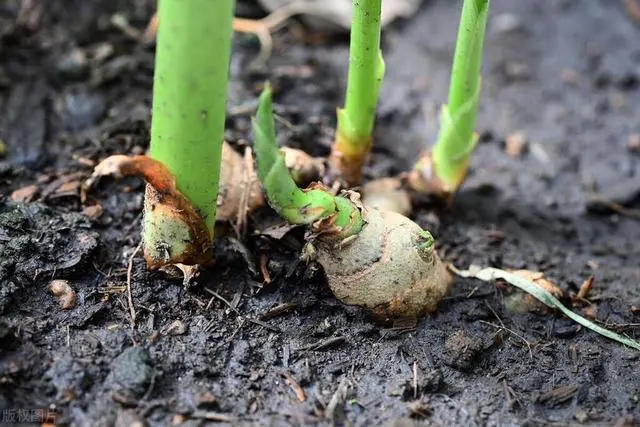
[252, 85, 450, 320]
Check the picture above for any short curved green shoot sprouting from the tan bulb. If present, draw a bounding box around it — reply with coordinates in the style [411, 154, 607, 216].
[251, 84, 364, 237]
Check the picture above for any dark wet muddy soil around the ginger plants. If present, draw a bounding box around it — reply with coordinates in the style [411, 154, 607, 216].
[0, 0, 640, 426]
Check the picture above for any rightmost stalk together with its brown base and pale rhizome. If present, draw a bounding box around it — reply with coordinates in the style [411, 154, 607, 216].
[363, 0, 490, 214]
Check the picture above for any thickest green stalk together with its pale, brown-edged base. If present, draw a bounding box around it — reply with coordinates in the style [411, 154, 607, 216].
[143, 0, 235, 265]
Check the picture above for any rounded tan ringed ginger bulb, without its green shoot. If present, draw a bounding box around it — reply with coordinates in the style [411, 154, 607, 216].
[316, 209, 452, 320]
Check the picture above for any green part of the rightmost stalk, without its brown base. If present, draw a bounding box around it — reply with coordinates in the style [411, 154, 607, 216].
[433, 0, 490, 185]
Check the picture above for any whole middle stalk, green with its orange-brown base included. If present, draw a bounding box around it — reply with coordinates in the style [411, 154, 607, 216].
[332, 0, 385, 184]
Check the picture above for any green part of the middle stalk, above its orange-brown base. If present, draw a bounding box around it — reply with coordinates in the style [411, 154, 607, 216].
[338, 0, 385, 144]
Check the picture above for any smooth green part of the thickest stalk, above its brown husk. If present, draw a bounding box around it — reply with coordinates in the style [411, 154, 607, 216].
[150, 0, 235, 235]
